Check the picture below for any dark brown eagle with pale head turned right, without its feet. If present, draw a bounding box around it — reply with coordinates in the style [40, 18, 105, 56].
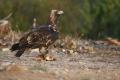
[10, 10, 64, 57]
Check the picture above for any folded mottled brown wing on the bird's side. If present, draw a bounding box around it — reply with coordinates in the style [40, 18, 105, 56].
[19, 27, 53, 48]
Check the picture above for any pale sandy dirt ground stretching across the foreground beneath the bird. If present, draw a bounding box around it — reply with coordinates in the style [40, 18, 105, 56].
[0, 41, 120, 80]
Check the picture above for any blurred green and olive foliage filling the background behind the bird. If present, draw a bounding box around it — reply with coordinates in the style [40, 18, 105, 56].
[0, 0, 120, 39]
